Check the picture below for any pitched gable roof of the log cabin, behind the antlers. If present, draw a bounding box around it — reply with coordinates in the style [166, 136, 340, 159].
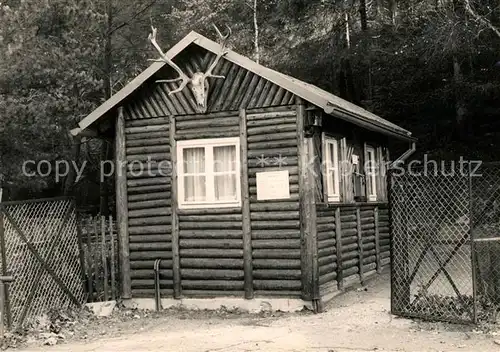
[73, 31, 415, 140]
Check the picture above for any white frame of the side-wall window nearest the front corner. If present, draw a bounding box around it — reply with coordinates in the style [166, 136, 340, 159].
[323, 135, 342, 203]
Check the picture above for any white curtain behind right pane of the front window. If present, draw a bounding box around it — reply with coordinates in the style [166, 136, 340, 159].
[214, 145, 237, 201]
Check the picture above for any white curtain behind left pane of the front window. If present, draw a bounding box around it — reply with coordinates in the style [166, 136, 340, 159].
[183, 148, 207, 202]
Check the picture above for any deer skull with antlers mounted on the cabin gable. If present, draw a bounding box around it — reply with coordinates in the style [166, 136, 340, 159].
[148, 24, 231, 113]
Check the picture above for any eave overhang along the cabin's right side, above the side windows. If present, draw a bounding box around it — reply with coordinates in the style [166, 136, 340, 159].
[323, 103, 417, 142]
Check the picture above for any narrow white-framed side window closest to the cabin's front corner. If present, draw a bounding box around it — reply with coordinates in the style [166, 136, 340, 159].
[324, 137, 340, 202]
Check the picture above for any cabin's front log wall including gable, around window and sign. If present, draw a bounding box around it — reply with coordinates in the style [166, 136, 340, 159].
[120, 45, 301, 297]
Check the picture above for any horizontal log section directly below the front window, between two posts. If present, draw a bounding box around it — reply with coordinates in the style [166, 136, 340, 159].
[178, 208, 244, 297]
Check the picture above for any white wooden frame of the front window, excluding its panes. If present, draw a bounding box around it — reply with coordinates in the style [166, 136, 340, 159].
[176, 137, 241, 209]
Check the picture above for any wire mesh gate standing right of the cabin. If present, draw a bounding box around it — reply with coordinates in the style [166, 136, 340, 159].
[389, 163, 500, 322]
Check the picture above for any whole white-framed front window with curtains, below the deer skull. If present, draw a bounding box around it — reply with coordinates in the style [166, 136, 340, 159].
[177, 138, 241, 208]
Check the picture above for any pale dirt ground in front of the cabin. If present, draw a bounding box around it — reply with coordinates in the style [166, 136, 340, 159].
[13, 276, 500, 352]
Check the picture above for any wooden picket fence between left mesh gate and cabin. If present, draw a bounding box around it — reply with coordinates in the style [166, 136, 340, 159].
[80, 216, 119, 302]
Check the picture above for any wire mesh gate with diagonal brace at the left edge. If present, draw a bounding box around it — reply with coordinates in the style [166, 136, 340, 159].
[0, 198, 85, 329]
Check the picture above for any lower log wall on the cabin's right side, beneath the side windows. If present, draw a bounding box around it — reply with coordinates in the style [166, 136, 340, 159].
[317, 204, 390, 296]
